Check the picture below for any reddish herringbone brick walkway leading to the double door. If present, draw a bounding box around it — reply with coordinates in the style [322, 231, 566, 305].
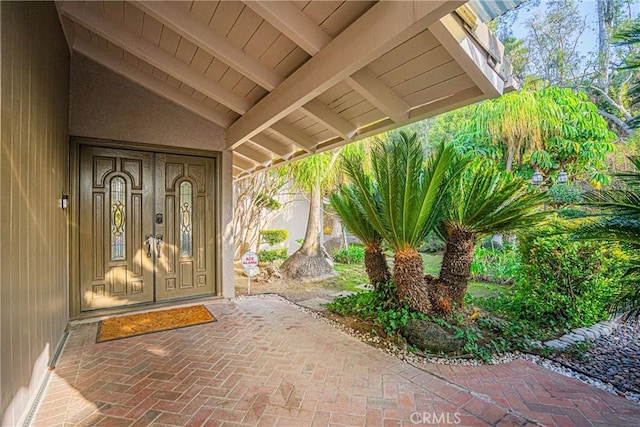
[33, 298, 640, 427]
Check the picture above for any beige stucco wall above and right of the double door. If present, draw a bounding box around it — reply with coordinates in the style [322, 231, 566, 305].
[69, 54, 234, 298]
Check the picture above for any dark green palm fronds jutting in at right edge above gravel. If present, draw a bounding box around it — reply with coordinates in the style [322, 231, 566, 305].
[576, 156, 640, 318]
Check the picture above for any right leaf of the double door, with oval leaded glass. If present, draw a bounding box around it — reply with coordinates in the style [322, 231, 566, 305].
[156, 153, 215, 301]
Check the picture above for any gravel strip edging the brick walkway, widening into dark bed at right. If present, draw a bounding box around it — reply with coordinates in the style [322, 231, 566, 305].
[235, 294, 640, 403]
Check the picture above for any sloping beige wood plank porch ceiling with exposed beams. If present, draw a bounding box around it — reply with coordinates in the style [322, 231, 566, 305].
[57, 0, 512, 178]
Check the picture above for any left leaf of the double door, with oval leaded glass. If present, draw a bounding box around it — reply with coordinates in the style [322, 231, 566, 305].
[78, 146, 154, 311]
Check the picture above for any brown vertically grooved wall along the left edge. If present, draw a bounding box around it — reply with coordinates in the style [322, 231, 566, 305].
[0, 2, 69, 426]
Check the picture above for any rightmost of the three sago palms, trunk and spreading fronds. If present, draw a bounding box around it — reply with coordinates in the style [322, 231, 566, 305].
[438, 161, 550, 312]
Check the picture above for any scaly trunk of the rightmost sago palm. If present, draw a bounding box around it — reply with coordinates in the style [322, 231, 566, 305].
[440, 229, 476, 308]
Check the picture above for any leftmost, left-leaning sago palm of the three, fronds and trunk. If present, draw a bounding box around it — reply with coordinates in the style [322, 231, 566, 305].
[329, 185, 391, 289]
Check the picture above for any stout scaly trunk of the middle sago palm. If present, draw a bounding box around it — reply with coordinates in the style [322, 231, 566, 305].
[393, 248, 431, 313]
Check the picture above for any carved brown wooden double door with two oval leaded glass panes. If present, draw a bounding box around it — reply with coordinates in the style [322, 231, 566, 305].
[78, 145, 215, 311]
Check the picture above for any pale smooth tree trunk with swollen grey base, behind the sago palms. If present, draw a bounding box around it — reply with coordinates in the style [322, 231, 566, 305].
[280, 182, 336, 283]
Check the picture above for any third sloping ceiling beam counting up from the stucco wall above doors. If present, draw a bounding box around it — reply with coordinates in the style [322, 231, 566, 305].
[131, 0, 284, 91]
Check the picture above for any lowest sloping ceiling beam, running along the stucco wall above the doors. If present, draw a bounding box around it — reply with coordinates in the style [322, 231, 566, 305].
[72, 37, 233, 128]
